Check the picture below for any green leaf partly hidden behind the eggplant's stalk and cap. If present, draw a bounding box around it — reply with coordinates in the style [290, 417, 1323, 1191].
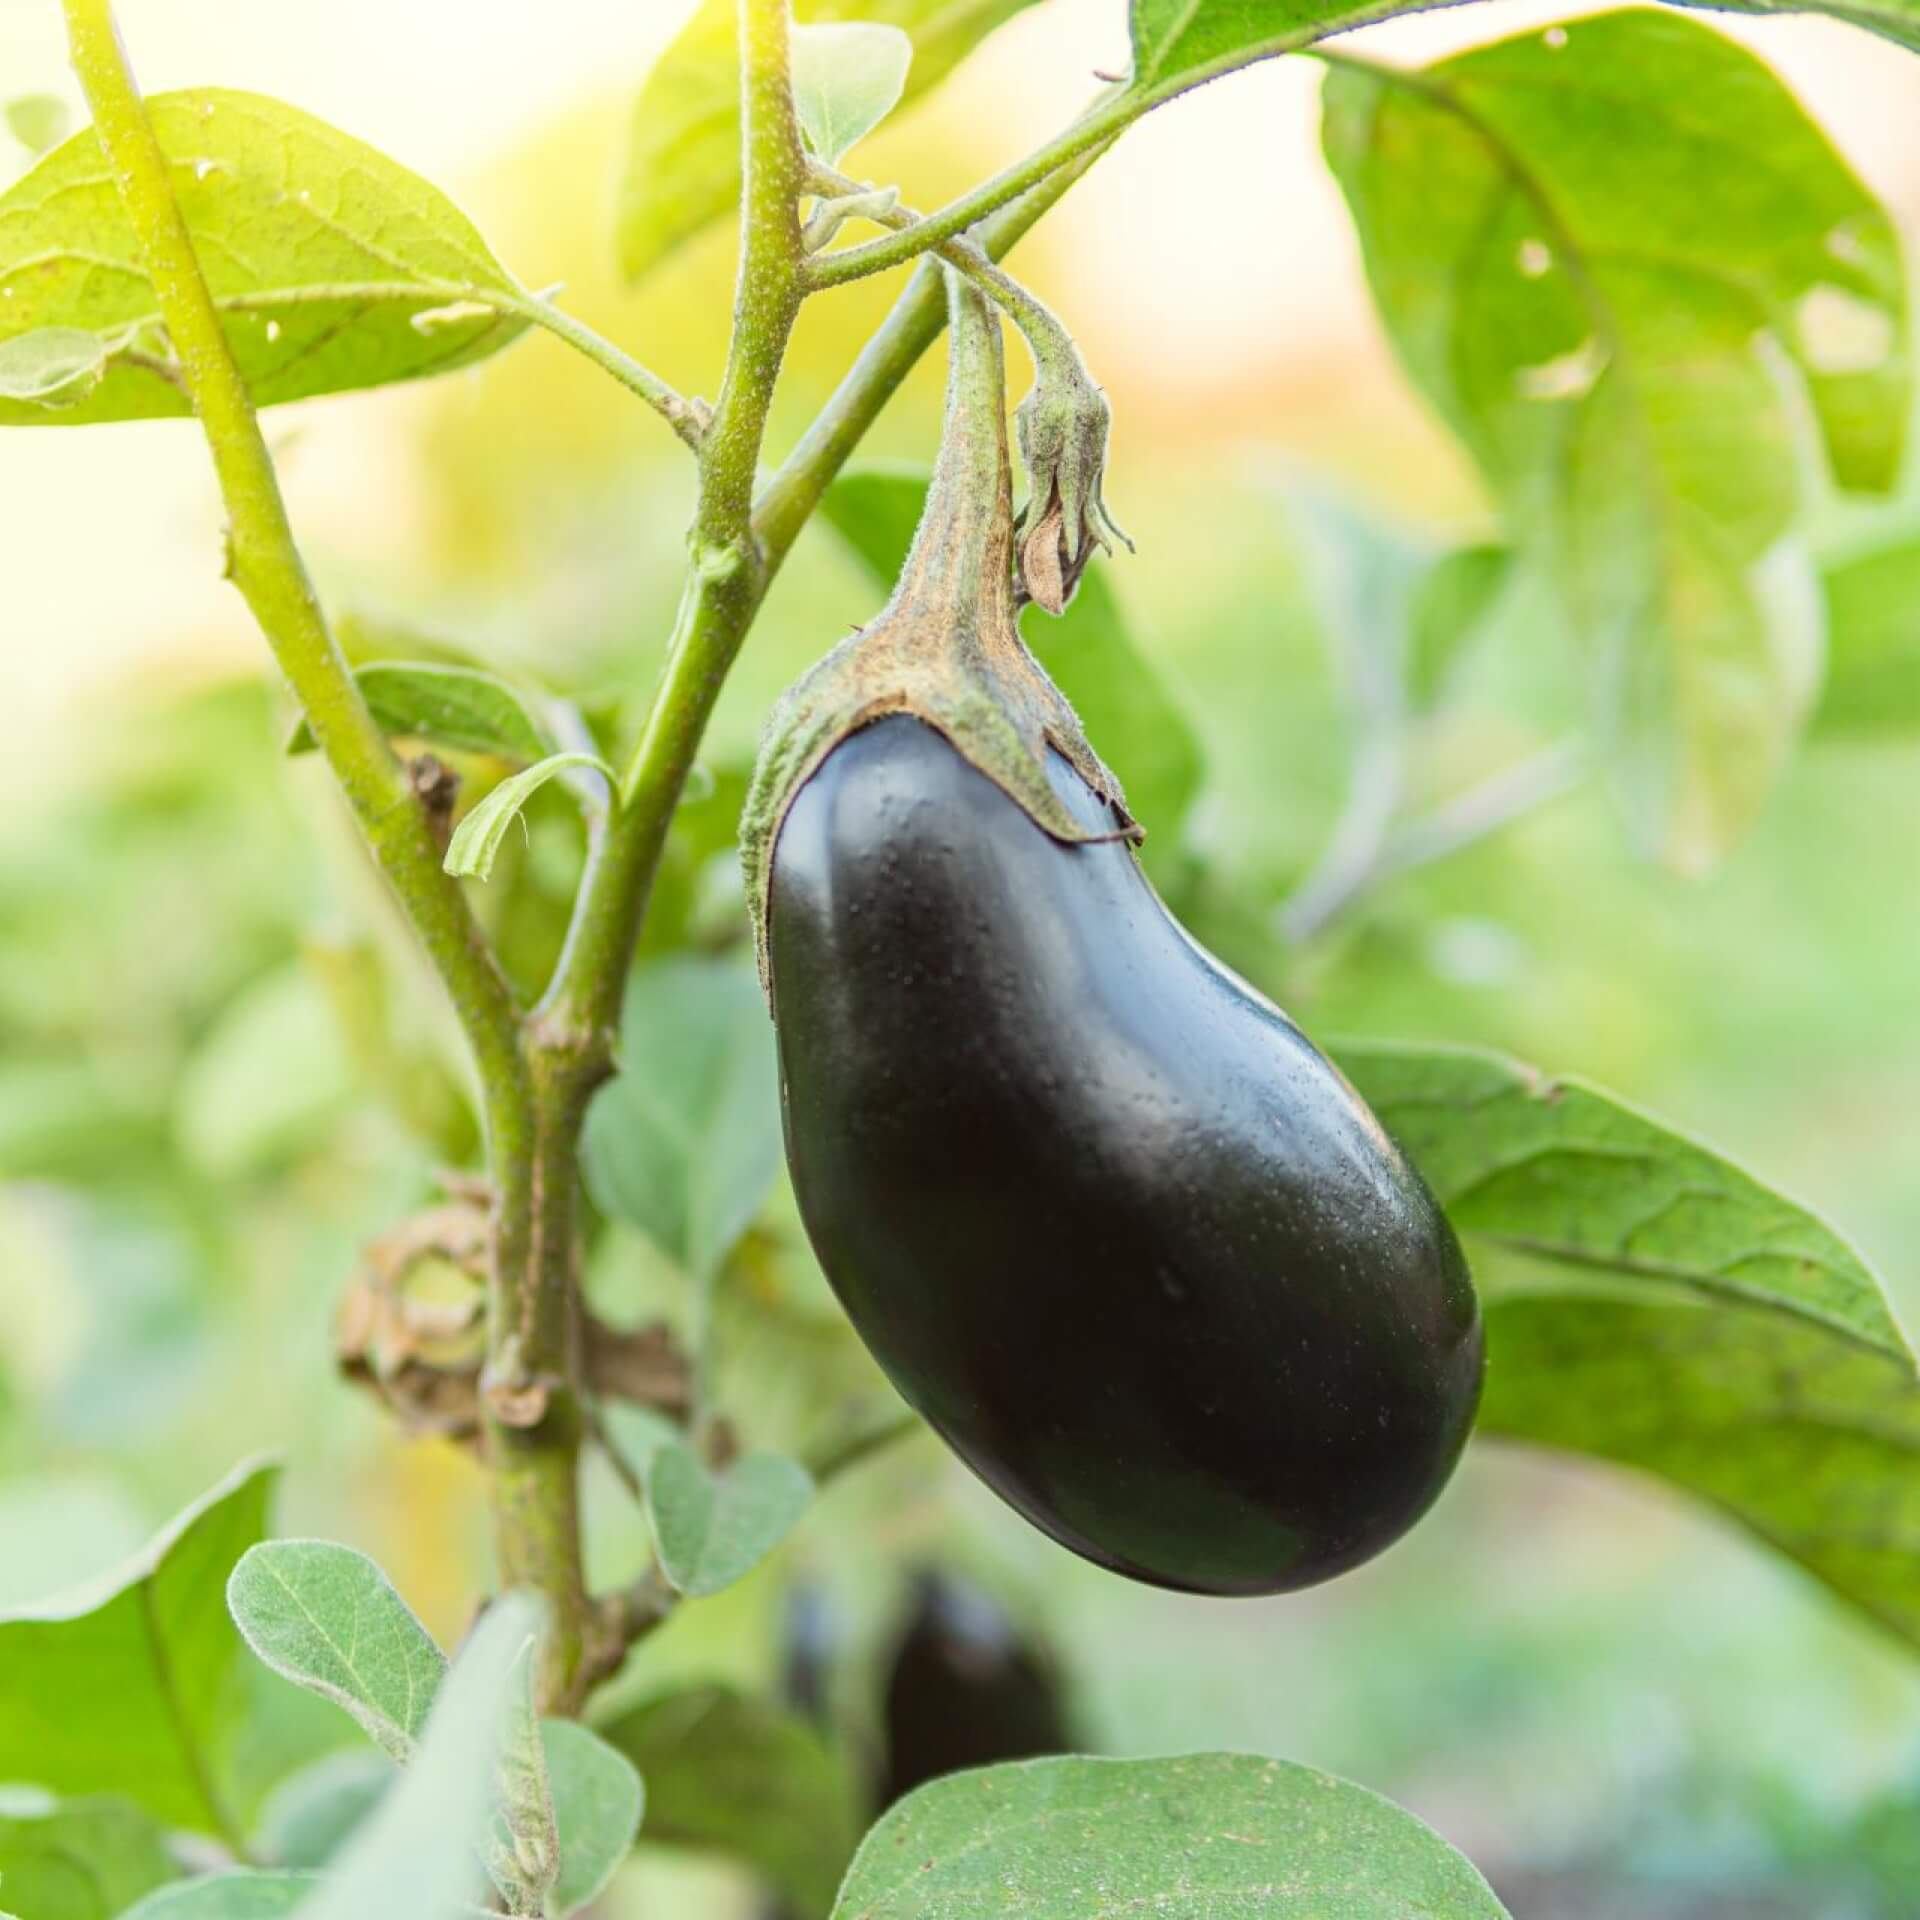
[820, 467, 1206, 848]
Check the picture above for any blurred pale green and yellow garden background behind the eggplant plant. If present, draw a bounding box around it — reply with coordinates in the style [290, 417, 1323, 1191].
[0, 0, 1920, 1920]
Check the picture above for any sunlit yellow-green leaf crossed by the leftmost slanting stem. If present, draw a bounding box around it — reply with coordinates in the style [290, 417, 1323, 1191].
[0, 88, 526, 426]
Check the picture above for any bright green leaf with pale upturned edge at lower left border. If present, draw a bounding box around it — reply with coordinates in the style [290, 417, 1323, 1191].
[0, 1465, 278, 1837]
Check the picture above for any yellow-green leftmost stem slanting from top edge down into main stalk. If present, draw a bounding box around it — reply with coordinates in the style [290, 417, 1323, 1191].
[63, 0, 622, 1707]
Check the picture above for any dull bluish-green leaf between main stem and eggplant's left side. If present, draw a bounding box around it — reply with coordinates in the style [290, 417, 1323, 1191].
[582, 954, 780, 1281]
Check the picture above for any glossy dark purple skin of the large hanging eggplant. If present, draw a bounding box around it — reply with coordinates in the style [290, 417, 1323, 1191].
[770, 714, 1480, 1594]
